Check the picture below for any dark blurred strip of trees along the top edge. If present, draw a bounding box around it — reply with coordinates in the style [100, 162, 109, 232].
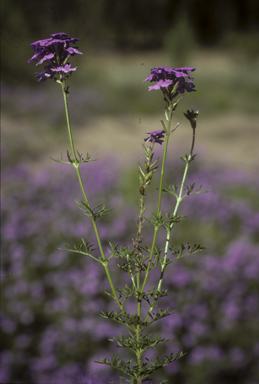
[1, 0, 259, 82]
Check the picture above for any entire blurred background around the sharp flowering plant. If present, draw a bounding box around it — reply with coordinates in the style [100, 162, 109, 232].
[0, 0, 259, 384]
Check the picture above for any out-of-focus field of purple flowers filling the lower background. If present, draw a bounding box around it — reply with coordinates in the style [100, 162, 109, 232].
[0, 160, 259, 384]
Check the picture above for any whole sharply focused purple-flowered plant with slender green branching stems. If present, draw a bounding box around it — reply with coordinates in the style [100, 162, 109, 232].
[28, 33, 204, 384]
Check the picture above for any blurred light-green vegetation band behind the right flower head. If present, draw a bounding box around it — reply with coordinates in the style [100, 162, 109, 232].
[75, 46, 259, 114]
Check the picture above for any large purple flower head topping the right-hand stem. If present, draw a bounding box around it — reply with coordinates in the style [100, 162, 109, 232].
[144, 67, 196, 101]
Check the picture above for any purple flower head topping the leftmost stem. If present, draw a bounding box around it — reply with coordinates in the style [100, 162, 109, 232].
[28, 32, 82, 81]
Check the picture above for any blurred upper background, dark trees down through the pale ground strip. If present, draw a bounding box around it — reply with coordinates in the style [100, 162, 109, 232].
[1, 0, 259, 170]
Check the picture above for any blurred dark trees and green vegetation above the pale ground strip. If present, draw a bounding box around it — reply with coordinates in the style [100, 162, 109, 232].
[1, 0, 259, 123]
